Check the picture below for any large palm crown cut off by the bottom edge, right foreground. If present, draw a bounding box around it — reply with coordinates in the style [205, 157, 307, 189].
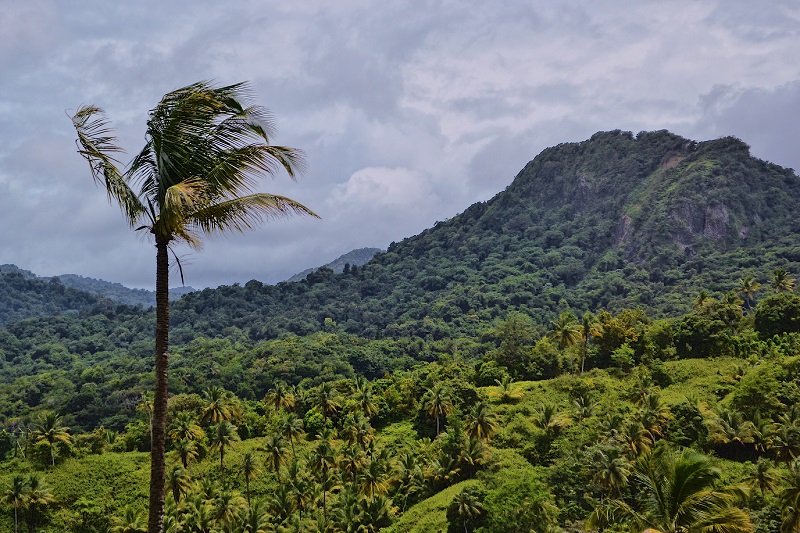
[586, 446, 753, 533]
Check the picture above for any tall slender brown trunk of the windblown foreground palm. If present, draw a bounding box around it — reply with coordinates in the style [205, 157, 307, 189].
[147, 239, 169, 533]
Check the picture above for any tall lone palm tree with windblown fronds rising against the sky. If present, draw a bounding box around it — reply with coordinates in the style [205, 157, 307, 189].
[72, 82, 316, 533]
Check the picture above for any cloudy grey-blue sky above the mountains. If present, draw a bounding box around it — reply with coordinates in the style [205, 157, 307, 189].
[0, 0, 800, 289]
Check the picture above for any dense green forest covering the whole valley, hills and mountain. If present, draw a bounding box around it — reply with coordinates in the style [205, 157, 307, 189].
[0, 131, 800, 533]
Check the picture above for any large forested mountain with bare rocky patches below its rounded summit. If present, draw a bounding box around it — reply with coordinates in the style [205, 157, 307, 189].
[169, 131, 800, 340]
